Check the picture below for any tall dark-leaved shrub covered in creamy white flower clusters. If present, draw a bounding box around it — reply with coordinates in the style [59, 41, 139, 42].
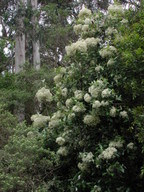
[29, 5, 144, 192]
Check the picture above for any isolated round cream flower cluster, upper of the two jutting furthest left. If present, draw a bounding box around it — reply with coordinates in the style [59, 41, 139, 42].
[36, 87, 53, 102]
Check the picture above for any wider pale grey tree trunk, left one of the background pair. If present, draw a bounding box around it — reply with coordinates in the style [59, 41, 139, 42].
[15, 0, 25, 73]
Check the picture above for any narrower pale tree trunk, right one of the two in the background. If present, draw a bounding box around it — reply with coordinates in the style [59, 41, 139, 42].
[31, 0, 40, 69]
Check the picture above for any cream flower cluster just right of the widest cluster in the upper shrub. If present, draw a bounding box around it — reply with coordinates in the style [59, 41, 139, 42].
[99, 46, 117, 58]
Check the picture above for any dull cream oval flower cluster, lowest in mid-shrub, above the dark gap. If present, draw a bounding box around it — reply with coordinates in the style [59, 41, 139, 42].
[83, 115, 100, 126]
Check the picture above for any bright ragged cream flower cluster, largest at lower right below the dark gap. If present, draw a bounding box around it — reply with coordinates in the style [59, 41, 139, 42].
[98, 147, 117, 160]
